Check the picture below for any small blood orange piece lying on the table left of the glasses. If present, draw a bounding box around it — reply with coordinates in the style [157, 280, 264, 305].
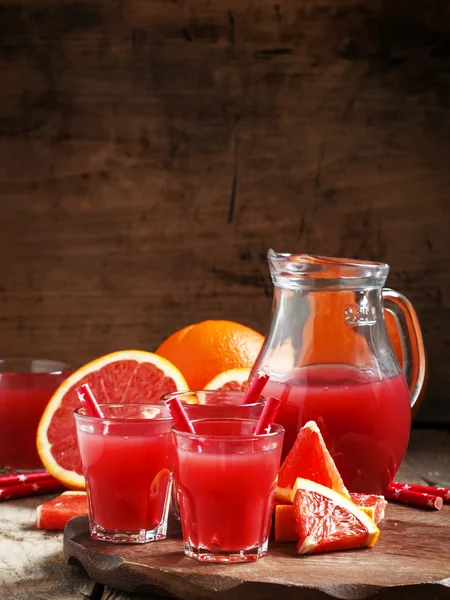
[36, 492, 88, 530]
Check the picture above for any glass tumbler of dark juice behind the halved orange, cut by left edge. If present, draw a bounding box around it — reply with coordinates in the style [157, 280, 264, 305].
[0, 358, 73, 471]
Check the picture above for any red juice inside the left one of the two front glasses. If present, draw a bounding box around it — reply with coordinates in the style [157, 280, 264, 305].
[78, 431, 174, 531]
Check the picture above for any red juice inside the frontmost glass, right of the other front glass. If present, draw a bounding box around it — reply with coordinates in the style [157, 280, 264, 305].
[175, 423, 281, 551]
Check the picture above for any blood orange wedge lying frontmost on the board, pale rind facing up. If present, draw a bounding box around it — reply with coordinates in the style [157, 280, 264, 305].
[293, 478, 380, 554]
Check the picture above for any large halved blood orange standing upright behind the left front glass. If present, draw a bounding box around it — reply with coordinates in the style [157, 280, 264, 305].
[36, 350, 188, 489]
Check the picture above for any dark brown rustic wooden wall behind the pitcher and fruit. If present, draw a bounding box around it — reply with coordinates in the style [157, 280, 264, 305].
[0, 0, 450, 423]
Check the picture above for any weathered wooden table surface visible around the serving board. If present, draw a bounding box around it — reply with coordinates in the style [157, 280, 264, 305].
[0, 429, 450, 600]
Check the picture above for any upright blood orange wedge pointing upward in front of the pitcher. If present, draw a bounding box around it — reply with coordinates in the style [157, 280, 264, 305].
[275, 421, 350, 502]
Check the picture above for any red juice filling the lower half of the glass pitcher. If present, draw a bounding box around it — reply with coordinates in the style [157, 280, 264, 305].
[264, 365, 411, 494]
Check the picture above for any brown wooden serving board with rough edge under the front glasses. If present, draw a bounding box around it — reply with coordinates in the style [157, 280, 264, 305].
[64, 504, 450, 600]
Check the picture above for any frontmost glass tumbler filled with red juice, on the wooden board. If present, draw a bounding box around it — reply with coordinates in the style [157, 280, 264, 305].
[172, 419, 284, 563]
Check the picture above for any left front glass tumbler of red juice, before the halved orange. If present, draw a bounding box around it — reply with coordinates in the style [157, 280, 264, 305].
[75, 404, 175, 543]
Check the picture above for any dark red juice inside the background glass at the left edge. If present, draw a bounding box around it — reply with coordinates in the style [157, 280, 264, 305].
[0, 382, 67, 470]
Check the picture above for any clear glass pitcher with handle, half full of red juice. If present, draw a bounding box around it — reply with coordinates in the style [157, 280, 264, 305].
[250, 250, 425, 494]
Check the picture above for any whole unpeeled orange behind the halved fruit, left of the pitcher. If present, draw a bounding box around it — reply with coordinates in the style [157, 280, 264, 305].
[156, 321, 264, 390]
